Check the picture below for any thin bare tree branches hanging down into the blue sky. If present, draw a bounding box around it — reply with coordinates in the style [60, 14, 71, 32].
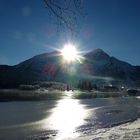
[44, 0, 85, 34]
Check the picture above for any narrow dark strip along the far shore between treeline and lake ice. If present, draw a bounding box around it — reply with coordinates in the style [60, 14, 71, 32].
[0, 89, 137, 102]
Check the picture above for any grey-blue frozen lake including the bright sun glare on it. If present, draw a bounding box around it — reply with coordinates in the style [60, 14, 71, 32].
[0, 92, 140, 140]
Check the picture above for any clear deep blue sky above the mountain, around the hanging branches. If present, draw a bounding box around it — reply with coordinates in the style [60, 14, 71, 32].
[0, 0, 140, 65]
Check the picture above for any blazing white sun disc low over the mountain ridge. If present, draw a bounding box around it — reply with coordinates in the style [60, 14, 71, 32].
[61, 44, 78, 62]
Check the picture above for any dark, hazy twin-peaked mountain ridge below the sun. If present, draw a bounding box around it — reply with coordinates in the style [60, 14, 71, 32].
[0, 49, 140, 88]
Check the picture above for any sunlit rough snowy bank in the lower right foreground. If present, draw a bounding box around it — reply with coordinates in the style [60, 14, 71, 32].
[69, 119, 140, 140]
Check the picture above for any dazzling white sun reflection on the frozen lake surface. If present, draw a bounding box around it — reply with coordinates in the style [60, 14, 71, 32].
[46, 99, 86, 140]
